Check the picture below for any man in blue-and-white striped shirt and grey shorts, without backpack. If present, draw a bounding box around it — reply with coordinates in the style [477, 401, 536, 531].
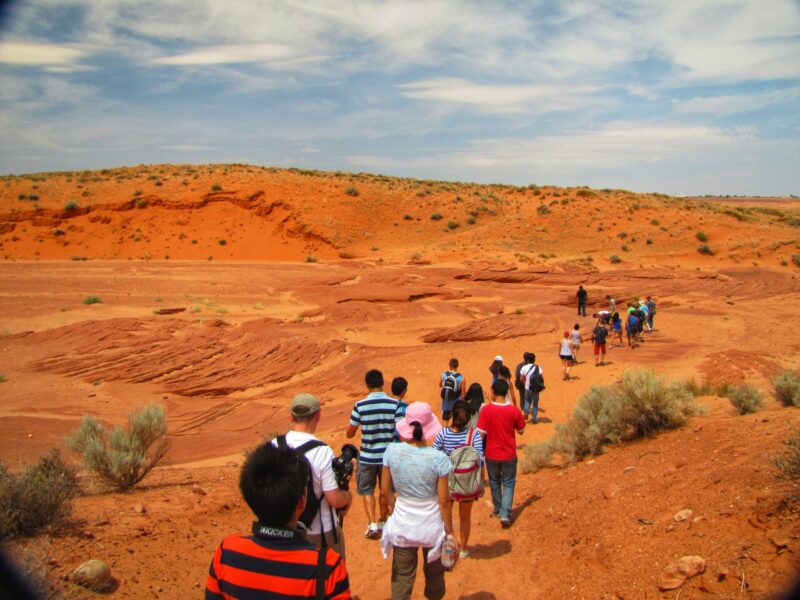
[347, 369, 407, 539]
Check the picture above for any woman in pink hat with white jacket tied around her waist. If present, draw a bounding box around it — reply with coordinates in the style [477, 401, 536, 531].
[381, 402, 453, 600]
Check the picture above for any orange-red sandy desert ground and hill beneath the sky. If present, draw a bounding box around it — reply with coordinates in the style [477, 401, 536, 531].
[0, 165, 800, 600]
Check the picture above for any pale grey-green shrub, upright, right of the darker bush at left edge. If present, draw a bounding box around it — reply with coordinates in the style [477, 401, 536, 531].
[66, 404, 168, 491]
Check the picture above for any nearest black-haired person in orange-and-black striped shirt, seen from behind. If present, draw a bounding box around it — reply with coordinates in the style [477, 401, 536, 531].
[205, 442, 351, 600]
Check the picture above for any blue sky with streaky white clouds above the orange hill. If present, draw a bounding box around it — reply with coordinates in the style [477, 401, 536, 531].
[0, 0, 800, 195]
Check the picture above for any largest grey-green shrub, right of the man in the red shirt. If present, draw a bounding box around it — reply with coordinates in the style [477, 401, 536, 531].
[554, 369, 697, 461]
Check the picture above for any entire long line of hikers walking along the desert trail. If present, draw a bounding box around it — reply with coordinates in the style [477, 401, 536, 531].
[206, 286, 655, 600]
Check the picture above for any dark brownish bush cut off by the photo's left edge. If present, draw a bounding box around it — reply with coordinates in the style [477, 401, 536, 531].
[0, 449, 78, 539]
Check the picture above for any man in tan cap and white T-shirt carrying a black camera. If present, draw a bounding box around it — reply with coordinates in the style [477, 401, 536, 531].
[272, 394, 352, 557]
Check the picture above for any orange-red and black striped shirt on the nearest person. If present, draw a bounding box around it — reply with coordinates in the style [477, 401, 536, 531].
[206, 528, 350, 600]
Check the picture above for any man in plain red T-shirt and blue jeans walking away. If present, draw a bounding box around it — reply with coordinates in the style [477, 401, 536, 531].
[478, 379, 525, 529]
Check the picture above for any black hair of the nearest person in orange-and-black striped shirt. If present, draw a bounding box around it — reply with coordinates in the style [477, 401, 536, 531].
[239, 442, 311, 527]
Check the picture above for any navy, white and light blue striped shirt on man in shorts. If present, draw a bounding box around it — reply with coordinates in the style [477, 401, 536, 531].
[350, 392, 407, 465]
